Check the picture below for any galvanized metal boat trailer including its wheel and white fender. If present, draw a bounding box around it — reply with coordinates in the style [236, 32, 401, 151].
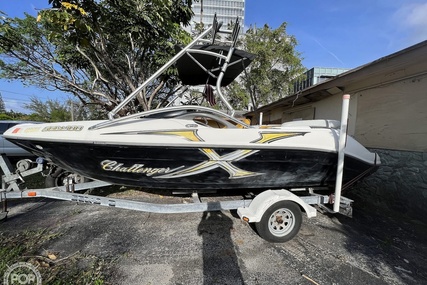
[0, 155, 353, 242]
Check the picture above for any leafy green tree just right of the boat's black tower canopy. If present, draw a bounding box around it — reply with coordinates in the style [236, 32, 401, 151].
[227, 23, 304, 109]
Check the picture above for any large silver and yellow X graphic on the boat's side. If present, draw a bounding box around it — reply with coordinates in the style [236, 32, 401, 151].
[152, 130, 304, 179]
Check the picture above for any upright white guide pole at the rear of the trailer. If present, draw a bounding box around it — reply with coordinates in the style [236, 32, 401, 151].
[334, 94, 350, 212]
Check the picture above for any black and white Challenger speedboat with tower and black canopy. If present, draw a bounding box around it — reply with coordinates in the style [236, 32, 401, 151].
[4, 16, 380, 192]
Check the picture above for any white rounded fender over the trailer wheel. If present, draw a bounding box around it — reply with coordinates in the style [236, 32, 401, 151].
[237, 190, 317, 223]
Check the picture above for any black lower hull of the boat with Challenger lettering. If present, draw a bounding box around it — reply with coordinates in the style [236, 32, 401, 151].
[10, 136, 376, 191]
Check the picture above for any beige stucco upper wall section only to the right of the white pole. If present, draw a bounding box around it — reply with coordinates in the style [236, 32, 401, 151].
[354, 75, 427, 152]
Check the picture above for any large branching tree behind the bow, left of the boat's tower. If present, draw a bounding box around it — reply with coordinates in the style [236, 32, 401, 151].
[0, 0, 192, 115]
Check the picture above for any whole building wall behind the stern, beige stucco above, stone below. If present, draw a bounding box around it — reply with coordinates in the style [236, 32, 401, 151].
[270, 74, 427, 217]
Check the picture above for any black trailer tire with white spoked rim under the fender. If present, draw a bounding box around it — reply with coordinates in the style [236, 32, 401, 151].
[255, 201, 302, 242]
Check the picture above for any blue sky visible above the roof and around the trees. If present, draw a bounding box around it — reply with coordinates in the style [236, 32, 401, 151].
[0, 0, 427, 112]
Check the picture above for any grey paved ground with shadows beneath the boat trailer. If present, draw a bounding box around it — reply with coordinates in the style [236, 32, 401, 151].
[0, 191, 427, 285]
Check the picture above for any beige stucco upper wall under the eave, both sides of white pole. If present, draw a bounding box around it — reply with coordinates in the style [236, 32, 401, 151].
[280, 75, 427, 152]
